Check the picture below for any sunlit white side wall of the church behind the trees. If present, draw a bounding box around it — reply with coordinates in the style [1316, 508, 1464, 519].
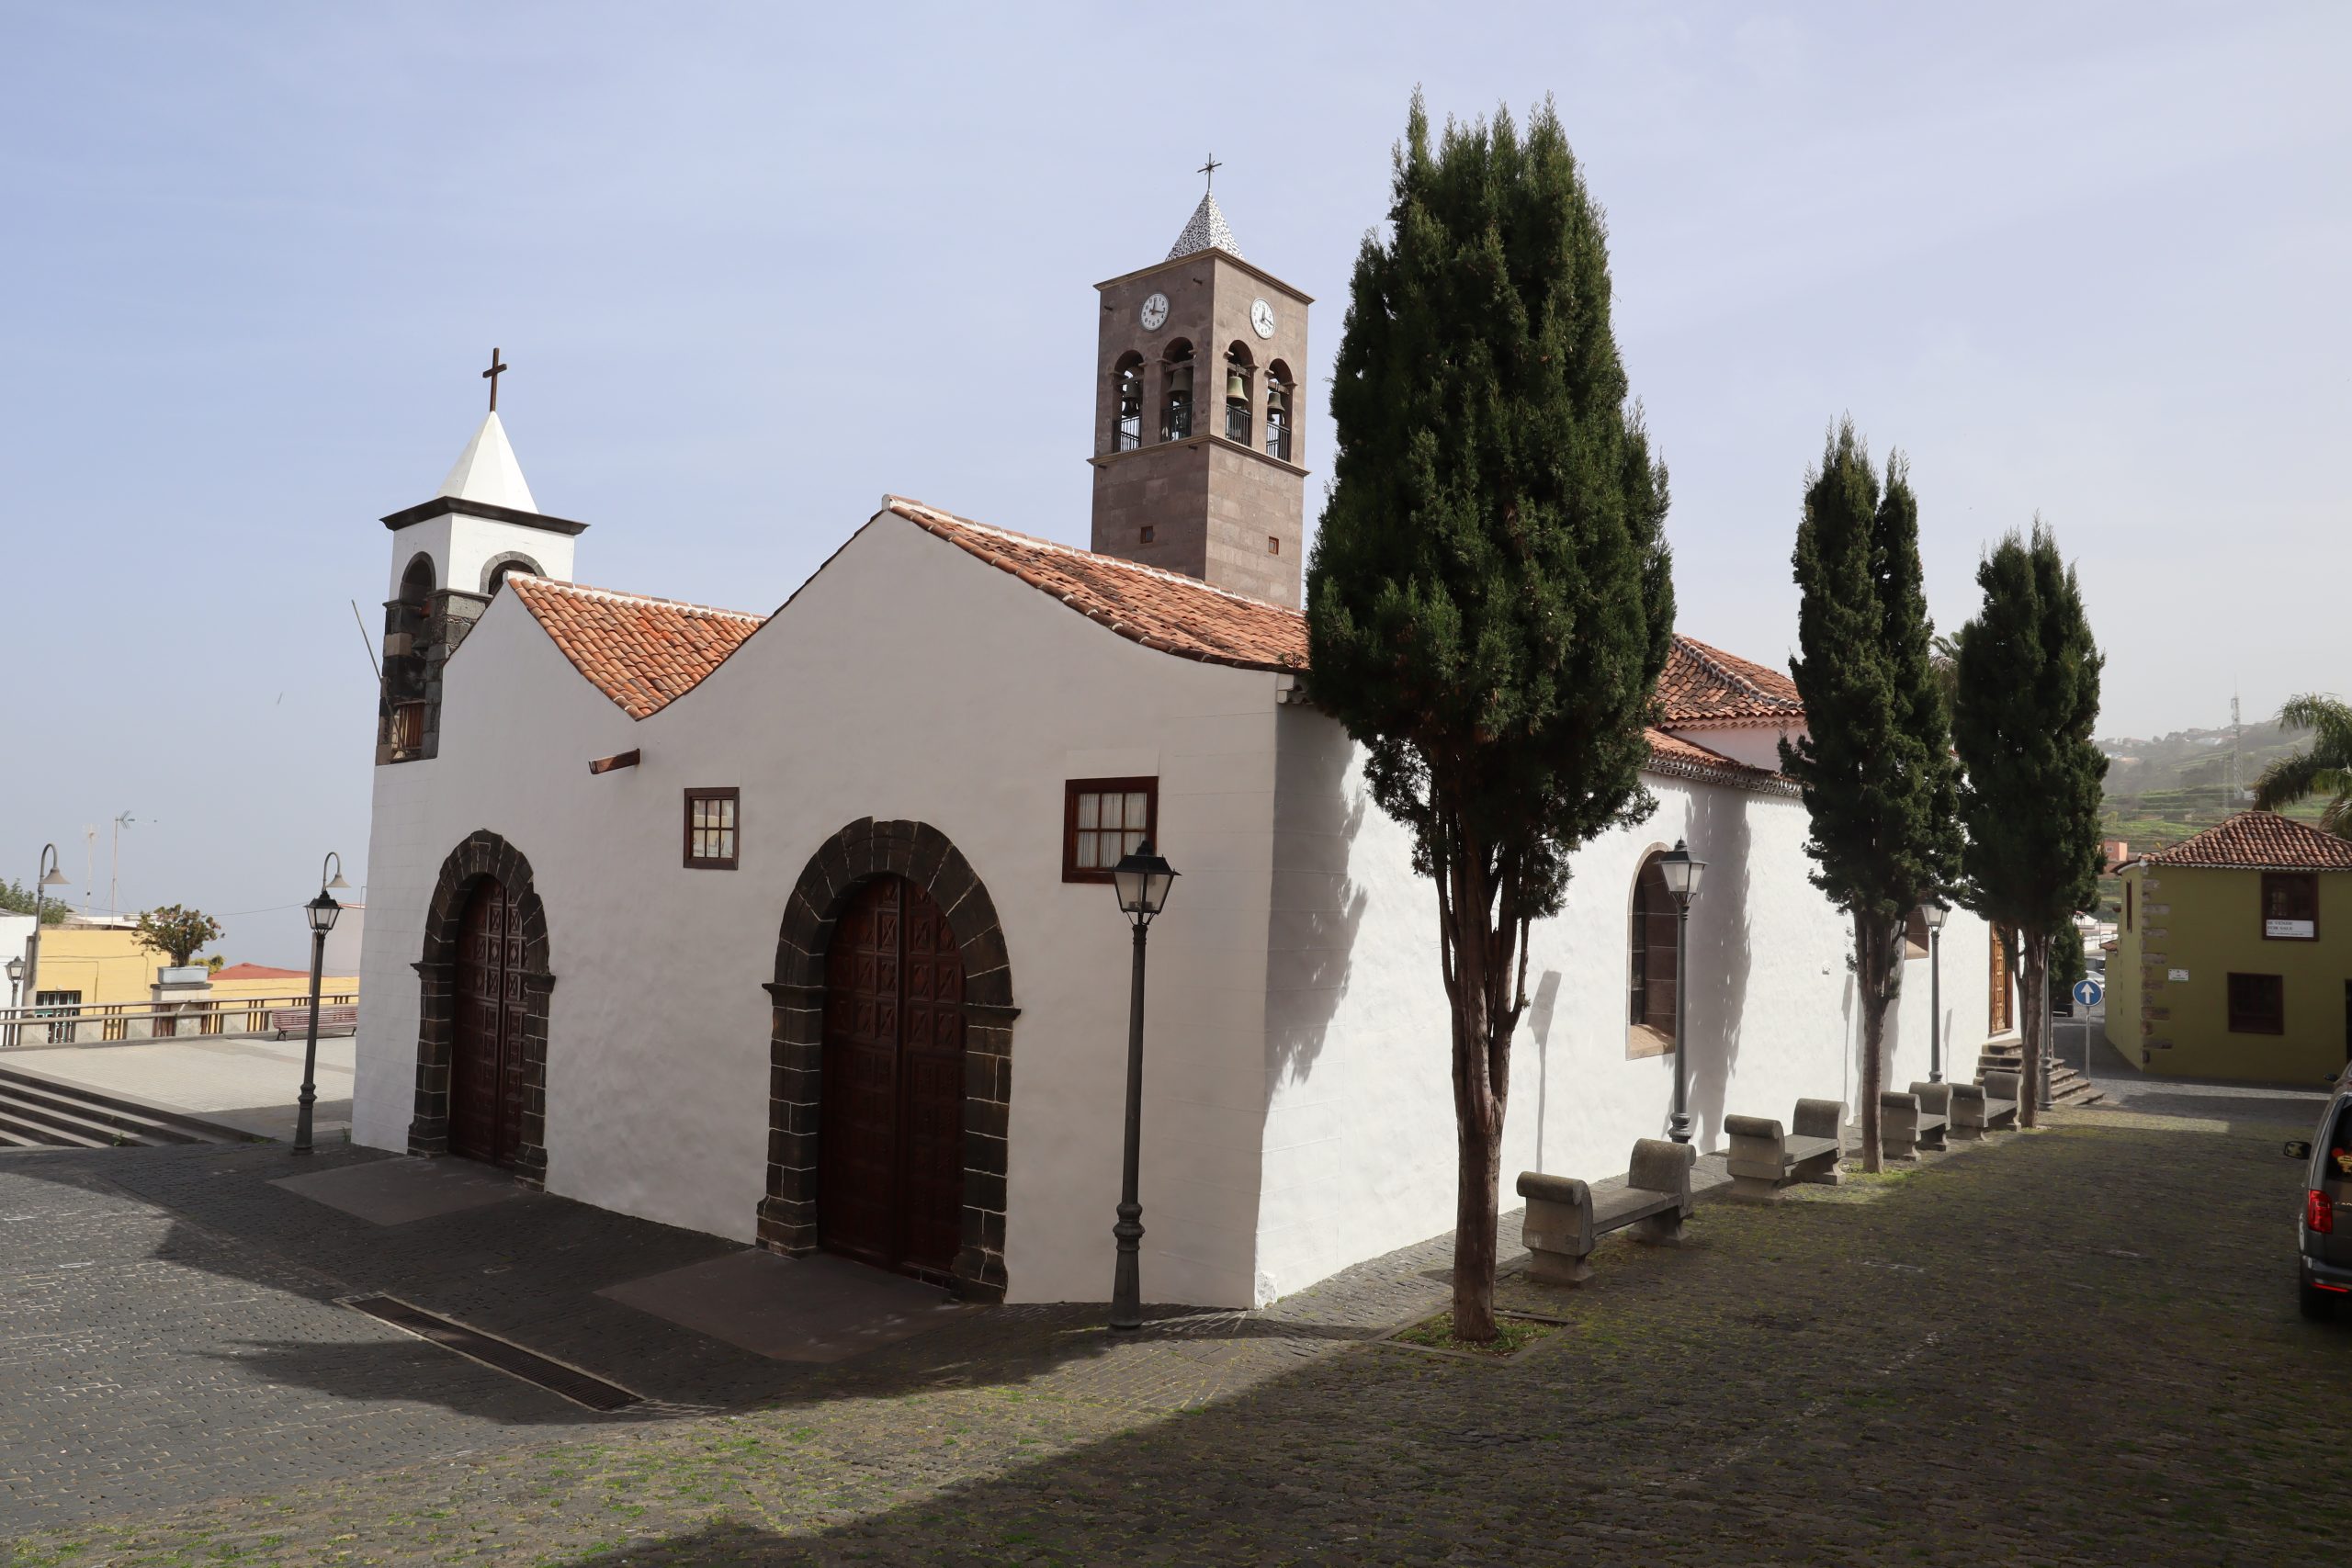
[1256, 707, 1987, 1300]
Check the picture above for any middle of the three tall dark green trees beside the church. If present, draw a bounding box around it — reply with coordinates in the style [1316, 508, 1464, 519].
[1781, 419, 1959, 1170]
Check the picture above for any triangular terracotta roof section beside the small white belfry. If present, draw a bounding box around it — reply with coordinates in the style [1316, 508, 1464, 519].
[505, 573, 767, 719]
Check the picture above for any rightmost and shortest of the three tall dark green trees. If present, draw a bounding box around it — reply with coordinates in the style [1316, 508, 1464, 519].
[1952, 517, 2108, 1126]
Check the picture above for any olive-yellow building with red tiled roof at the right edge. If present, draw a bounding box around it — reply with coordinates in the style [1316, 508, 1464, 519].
[2108, 811, 2352, 1084]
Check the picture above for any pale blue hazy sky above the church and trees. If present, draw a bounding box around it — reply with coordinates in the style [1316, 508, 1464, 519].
[0, 0, 2352, 962]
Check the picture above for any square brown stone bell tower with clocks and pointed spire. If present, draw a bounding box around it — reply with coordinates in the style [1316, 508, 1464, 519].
[1091, 179, 1315, 609]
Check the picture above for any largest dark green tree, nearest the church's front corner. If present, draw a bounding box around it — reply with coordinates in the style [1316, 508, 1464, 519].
[1307, 94, 1675, 1340]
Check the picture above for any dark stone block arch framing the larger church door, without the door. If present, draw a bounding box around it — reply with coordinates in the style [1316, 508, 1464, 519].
[760, 818, 1021, 1300]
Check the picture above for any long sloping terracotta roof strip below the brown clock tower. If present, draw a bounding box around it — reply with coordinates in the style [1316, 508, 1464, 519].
[882, 496, 1307, 670]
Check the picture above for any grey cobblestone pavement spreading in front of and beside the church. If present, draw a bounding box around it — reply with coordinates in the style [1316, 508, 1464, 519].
[0, 1096, 2352, 1568]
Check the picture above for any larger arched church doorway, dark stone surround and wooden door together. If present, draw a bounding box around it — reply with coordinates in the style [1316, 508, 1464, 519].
[760, 818, 1021, 1300]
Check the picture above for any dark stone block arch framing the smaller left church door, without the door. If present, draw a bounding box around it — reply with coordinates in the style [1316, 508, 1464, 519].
[409, 828, 555, 1185]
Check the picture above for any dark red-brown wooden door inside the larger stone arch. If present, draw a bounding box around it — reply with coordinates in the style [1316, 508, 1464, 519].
[816, 877, 965, 1274]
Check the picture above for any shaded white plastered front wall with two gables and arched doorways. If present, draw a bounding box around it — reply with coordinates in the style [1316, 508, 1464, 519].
[356, 514, 1275, 1304]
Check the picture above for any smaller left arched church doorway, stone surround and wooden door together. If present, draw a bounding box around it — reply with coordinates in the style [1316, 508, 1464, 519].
[409, 832, 555, 1182]
